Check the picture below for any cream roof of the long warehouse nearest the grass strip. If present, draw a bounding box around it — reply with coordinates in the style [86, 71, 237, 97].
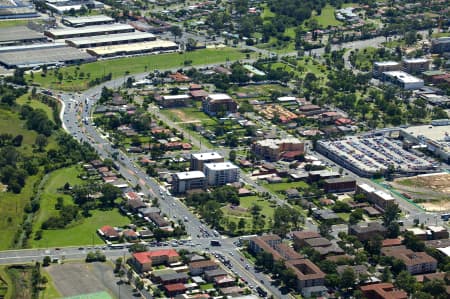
[89, 39, 178, 56]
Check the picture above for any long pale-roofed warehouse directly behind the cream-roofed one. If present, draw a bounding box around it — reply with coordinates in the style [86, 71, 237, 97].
[66, 32, 156, 48]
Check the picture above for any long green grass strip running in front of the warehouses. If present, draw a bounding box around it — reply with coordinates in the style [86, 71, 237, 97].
[26, 48, 250, 91]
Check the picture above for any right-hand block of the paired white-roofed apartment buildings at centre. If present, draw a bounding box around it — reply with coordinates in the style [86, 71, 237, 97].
[203, 162, 239, 186]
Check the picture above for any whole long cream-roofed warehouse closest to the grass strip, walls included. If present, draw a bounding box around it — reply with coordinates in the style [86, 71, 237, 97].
[87, 39, 179, 57]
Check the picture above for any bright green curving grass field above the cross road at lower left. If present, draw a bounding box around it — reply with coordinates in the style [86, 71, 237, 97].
[30, 166, 129, 248]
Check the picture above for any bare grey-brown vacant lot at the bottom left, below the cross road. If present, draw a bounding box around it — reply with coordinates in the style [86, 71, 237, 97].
[46, 263, 133, 299]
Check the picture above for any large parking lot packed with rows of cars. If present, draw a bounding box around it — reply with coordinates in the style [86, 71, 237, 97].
[320, 136, 435, 174]
